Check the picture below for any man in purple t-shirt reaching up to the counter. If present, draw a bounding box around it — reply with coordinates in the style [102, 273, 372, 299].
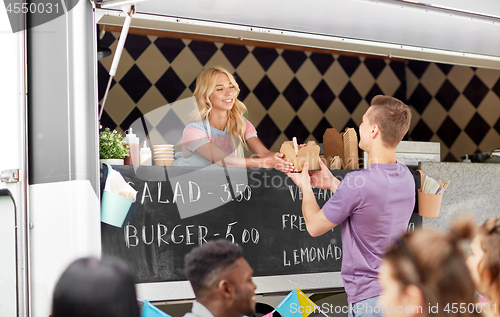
[288, 95, 415, 317]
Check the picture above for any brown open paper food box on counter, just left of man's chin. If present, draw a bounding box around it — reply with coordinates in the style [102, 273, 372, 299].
[323, 128, 359, 170]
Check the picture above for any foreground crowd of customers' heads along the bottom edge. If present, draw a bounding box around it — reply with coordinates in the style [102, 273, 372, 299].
[52, 217, 500, 317]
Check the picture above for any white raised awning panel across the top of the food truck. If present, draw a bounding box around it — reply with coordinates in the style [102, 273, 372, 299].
[96, 0, 500, 69]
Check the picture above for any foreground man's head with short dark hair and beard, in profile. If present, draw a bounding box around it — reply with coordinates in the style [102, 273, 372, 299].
[185, 240, 257, 317]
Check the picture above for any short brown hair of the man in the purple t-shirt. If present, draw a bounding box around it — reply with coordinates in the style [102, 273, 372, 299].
[368, 95, 411, 148]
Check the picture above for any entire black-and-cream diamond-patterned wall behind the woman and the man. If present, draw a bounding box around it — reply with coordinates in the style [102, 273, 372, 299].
[98, 32, 500, 161]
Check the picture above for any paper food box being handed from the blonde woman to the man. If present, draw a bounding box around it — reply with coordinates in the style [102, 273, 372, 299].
[280, 141, 320, 172]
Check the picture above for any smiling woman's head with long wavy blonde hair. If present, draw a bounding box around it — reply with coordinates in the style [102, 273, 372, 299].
[193, 66, 247, 144]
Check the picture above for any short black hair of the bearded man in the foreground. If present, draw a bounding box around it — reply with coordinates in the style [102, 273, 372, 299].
[184, 239, 243, 296]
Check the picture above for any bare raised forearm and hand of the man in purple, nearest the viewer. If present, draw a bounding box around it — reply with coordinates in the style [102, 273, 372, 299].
[287, 162, 337, 237]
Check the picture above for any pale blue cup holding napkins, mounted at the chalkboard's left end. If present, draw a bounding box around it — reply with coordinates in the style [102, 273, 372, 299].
[101, 190, 133, 228]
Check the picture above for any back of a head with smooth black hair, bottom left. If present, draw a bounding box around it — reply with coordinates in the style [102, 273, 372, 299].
[52, 257, 139, 317]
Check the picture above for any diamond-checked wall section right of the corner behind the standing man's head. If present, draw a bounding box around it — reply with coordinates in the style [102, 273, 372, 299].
[406, 61, 500, 161]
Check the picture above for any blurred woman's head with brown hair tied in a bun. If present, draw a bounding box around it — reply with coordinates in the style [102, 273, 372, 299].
[378, 220, 479, 317]
